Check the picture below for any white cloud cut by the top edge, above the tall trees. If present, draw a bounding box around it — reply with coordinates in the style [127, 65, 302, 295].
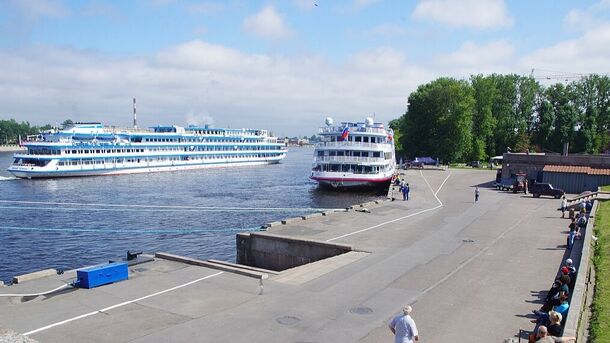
[413, 0, 514, 29]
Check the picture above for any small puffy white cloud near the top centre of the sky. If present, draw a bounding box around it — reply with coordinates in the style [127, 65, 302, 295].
[242, 5, 292, 40]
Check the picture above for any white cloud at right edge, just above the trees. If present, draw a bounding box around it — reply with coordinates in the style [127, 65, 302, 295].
[520, 24, 610, 73]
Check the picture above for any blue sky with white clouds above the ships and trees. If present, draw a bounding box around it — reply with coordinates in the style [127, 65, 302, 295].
[0, 0, 610, 136]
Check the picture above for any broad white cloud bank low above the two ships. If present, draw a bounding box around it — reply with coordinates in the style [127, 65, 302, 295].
[0, 40, 433, 136]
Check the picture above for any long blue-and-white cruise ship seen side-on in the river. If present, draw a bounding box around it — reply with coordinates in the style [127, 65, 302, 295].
[8, 123, 287, 178]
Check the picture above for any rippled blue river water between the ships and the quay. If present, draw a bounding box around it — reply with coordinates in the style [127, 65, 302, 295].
[0, 148, 378, 281]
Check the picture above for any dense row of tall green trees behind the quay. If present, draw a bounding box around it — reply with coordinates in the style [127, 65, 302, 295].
[390, 74, 610, 162]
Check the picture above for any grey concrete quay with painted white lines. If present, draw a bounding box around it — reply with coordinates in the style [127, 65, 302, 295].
[0, 170, 568, 342]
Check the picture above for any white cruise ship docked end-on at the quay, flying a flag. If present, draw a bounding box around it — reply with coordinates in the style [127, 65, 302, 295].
[311, 118, 396, 189]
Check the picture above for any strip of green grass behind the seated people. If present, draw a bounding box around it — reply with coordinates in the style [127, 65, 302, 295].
[590, 186, 610, 342]
